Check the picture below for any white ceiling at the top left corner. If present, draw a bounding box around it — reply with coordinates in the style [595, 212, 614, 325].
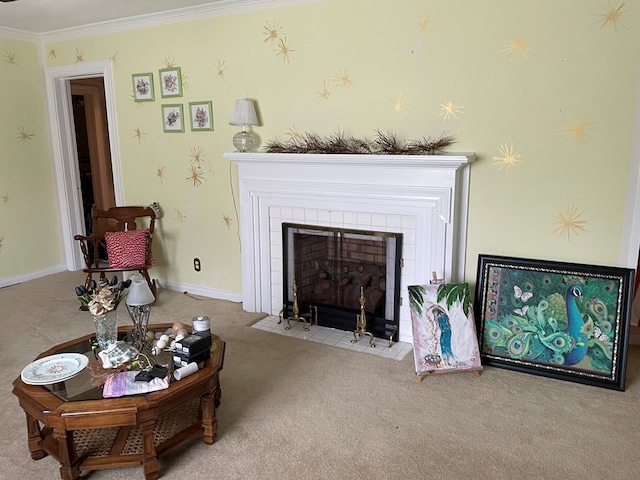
[0, 0, 231, 34]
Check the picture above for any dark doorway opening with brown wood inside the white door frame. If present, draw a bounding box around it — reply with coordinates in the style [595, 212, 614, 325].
[69, 77, 116, 235]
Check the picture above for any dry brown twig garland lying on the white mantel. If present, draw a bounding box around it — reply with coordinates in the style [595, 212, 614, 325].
[264, 130, 455, 155]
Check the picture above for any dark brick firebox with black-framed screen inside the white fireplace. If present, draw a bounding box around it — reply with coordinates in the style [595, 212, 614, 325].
[282, 223, 402, 341]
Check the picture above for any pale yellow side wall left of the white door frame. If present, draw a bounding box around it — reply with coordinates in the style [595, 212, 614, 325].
[0, 38, 64, 281]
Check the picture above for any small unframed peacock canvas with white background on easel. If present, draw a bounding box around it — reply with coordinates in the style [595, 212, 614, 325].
[408, 283, 482, 376]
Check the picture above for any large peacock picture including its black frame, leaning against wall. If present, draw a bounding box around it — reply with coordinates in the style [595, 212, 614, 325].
[475, 255, 634, 391]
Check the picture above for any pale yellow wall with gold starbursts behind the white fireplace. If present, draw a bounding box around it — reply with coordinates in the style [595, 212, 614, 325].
[0, 0, 640, 293]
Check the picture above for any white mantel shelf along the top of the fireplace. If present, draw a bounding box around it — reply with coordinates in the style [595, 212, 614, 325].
[224, 152, 475, 169]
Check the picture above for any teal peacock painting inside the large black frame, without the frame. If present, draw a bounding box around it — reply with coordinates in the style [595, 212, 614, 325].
[482, 266, 620, 375]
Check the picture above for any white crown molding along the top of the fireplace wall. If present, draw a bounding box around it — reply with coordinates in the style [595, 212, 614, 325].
[36, 0, 327, 43]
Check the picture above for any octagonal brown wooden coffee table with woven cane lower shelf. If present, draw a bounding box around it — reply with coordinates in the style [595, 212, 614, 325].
[13, 324, 225, 480]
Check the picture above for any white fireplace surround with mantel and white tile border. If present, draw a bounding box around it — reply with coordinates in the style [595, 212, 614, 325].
[224, 152, 474, 343]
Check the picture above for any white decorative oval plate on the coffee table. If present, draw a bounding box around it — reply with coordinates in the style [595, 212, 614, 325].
[20, 353, 89, 385]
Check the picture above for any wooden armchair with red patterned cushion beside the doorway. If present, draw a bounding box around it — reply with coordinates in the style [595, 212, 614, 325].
[73, 205, 156, 296]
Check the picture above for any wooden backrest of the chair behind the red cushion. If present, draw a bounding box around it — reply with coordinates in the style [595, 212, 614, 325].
[91, 205, 156, 265]
